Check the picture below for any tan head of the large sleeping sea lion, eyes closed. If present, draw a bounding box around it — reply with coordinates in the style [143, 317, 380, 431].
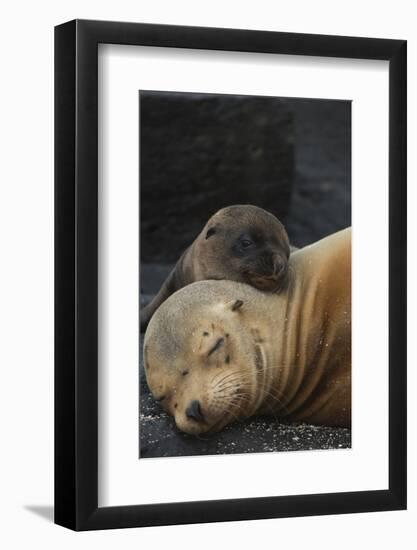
[144, 281, 269, 435]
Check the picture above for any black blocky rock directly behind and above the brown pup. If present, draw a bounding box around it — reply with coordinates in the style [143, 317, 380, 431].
[140, 92, 294, 263]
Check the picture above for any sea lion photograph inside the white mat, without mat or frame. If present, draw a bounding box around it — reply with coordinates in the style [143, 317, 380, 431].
[138, 90, 352, 459]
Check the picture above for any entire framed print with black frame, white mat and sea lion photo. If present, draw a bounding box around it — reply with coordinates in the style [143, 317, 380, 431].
[55, 20, 406, 530]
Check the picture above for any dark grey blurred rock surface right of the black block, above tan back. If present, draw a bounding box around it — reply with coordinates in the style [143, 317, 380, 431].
[285, 99, 351, 247]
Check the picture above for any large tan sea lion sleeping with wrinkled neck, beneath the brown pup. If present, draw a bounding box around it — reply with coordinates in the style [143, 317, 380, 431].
[144, 229, 351, 435]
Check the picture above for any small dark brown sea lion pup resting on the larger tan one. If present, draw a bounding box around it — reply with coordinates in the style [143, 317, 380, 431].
[140, 204, 290, 332]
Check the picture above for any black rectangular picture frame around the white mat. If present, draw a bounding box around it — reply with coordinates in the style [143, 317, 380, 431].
[55, 20, 407, 530]
